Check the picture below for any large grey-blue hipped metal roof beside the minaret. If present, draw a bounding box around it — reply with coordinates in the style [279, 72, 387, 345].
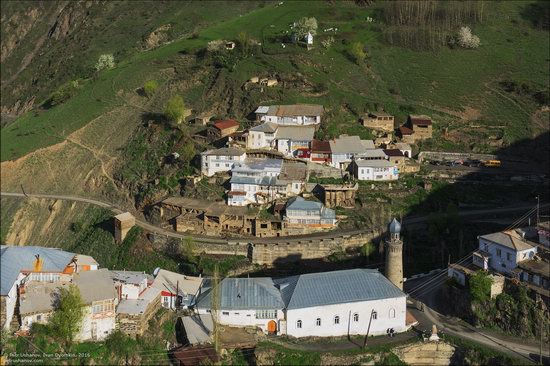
[275, 268, 406, 309]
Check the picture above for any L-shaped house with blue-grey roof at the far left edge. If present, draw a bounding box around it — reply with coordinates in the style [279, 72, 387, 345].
[0, 245, 99, 330]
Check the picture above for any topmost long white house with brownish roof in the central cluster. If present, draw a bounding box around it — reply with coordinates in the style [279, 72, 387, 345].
[255, 104, 324, 126]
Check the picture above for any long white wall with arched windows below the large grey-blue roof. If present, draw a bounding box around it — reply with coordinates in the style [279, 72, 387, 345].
[286, 296, 406, 337]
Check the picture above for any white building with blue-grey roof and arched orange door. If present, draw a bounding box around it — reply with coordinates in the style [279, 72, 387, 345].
[195, 277, 285, 334]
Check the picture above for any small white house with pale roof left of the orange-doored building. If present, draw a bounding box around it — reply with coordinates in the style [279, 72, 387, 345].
[152, 269, 203, 310]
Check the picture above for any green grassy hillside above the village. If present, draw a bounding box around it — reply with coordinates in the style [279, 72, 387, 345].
[1, 2, 549, 161]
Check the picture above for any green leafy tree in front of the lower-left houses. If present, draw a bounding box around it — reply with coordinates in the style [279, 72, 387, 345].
[50, 285, 84, 346]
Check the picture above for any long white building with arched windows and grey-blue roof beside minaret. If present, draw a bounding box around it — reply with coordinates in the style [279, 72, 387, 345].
[276, 269, 407, 338]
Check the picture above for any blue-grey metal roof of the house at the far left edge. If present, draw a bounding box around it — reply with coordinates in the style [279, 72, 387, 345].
[0, 245, 76, 295]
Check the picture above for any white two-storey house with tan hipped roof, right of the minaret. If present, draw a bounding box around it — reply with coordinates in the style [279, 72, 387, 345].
[473, 230, 537, 275]
